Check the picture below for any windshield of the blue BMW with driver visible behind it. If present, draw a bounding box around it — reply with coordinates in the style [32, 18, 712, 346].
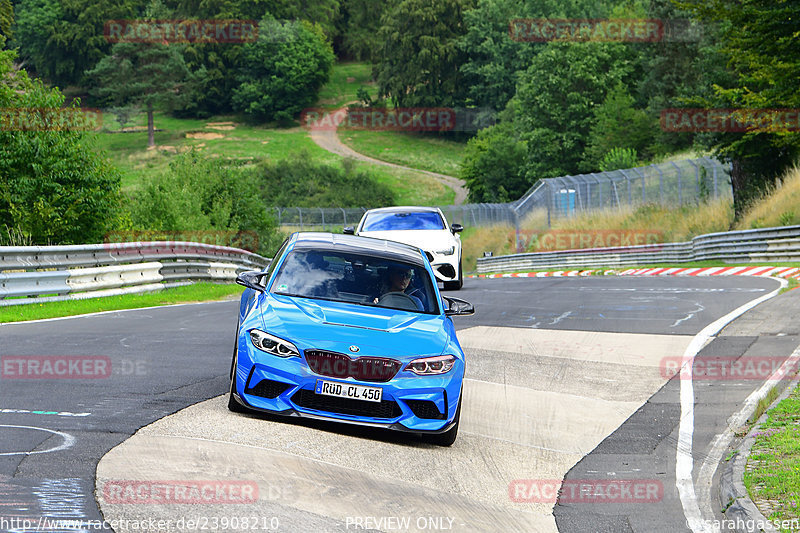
[271, 250, 439, 314]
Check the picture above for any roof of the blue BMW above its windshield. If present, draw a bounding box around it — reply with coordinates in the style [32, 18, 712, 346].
[292, 232, 425, 266]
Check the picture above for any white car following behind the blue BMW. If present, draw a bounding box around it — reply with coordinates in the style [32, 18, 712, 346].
[344, 206, 464, 290]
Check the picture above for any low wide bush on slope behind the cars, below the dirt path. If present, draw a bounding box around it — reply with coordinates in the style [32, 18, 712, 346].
[255, 152, 394, 207]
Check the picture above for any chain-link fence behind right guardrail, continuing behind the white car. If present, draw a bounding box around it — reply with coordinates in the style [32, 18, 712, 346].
[274, 157, 732, 231]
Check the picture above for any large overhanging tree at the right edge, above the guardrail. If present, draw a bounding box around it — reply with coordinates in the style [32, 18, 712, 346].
[678, 0, 800, 221]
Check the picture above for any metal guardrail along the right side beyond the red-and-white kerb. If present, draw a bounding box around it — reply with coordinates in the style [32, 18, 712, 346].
[478, 226, 800, 274]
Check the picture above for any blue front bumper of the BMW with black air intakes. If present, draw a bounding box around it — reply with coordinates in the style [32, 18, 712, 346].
[233, 337, 464, 433]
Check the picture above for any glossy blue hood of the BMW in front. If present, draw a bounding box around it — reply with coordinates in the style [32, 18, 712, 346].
[261, 294, 449, 359]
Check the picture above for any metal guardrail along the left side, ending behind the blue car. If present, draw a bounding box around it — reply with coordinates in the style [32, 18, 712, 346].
[0, 242, 270, 307]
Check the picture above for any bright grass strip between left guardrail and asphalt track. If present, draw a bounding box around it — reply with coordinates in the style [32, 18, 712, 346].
[0, 283, 244, 323]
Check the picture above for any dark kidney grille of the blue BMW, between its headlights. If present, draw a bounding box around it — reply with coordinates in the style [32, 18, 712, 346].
[305, 350, 403, 383]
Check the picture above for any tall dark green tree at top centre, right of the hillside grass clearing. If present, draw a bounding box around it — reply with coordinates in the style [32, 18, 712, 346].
[374, 0, 473, 107]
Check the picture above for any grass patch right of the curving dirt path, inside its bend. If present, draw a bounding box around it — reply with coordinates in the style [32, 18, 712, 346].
[339, 129, 467, 176]
